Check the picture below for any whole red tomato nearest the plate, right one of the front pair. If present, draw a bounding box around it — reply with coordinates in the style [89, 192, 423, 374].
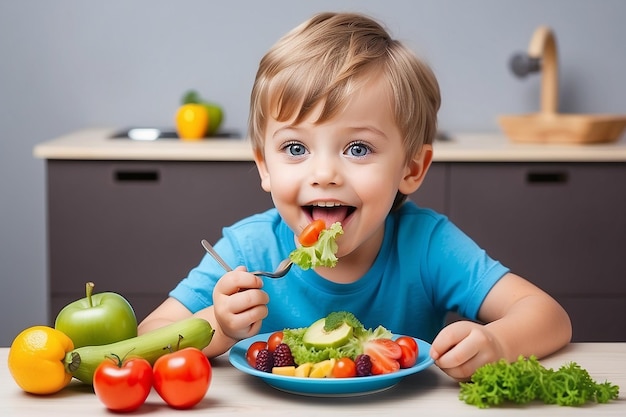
[153, 347, 212, 409]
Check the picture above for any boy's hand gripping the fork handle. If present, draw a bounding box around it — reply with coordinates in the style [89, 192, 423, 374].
[213, 266, 269, 340]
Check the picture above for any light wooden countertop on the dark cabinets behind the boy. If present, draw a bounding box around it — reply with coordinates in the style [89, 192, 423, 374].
[33, 129, 626, 162]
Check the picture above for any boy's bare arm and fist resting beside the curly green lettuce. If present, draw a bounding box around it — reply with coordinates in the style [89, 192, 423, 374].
[431, 273, 572, 380]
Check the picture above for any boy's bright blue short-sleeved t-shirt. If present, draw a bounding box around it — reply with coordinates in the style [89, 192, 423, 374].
[170, 201, 508, 342]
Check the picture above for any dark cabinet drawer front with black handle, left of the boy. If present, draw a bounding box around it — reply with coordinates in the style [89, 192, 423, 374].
[47, 160, 272, 317]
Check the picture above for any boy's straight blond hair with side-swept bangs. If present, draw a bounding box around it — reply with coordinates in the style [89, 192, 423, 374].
[248, 13, 441, 161]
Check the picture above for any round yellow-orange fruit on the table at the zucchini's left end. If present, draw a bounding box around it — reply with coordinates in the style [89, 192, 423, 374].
[8, 326, 74, 394]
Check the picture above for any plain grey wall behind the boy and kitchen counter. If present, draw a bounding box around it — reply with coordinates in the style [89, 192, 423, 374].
[0, 0, 626, 345]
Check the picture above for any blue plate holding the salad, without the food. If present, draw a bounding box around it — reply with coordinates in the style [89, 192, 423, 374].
[228, 333, 434, 397]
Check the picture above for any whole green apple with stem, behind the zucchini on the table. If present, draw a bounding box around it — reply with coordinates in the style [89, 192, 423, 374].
[54, 282, 137, 348]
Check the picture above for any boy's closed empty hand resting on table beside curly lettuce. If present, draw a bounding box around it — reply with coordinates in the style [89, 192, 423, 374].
[430, 321, 504, 381]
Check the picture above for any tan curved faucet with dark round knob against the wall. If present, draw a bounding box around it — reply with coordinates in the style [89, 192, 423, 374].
[510, 26, 559, 115]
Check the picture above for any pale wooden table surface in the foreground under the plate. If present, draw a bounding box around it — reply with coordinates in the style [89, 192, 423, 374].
[0, 343, 626, 417]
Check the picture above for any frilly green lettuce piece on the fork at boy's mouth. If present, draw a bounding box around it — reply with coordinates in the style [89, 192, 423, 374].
[289, 222, 343, 270]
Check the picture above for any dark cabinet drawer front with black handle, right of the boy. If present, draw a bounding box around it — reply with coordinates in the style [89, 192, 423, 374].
[449, 163, 626, 296]
